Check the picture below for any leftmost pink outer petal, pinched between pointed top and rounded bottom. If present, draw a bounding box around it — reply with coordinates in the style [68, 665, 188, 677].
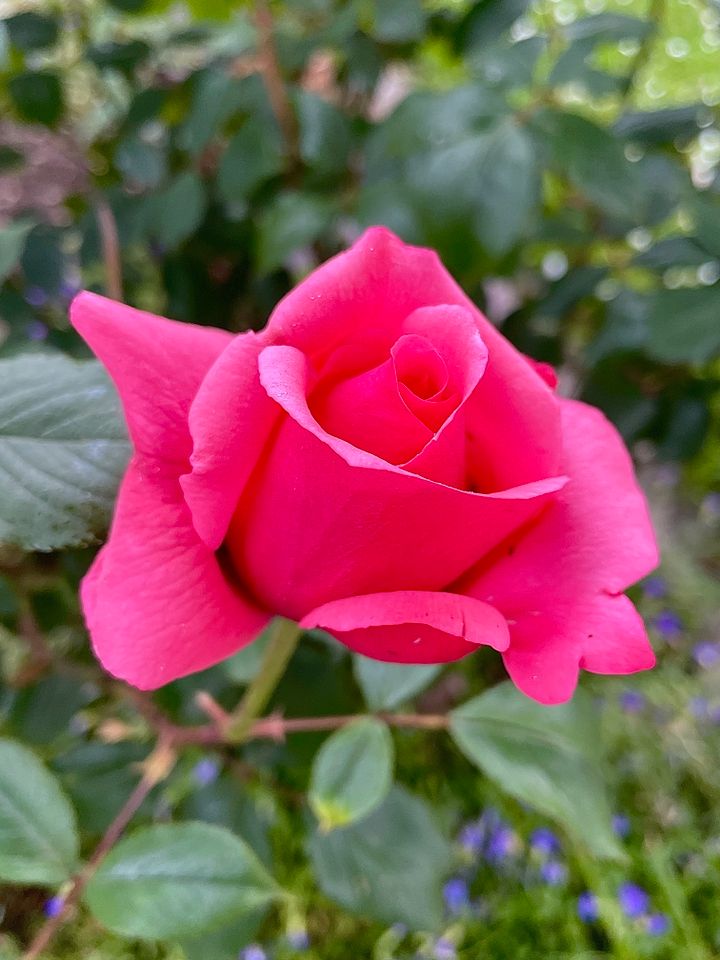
[71, 293, 267, 689]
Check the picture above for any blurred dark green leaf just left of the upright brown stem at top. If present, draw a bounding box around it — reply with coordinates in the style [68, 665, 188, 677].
[217, 117, 284, 202]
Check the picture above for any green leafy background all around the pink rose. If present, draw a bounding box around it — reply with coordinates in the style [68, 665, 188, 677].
[0, 0, 720, 960]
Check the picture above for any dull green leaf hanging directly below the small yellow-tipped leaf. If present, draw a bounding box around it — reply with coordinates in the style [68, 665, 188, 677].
[310, 787, 452, 930]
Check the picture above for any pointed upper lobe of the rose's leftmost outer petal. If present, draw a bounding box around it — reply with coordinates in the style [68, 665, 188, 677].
[70, 291, 232, 465]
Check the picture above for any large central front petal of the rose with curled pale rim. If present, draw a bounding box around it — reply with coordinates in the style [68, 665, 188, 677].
[227, 346, 565, 618]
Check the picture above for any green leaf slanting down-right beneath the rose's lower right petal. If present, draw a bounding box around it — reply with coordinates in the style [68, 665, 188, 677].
[450, 681, 622, 857]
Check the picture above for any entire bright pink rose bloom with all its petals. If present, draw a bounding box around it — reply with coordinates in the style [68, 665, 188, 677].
[72, 228, 657, 703]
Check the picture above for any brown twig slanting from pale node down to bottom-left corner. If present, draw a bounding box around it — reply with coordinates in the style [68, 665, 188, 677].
[22, 739, 176, 960]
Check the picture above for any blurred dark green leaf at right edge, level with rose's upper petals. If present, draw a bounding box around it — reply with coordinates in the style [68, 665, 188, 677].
[646, 284, 720, 364]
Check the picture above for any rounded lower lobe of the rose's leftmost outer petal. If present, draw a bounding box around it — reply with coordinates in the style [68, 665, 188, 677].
[81, 462, 268, 690]
